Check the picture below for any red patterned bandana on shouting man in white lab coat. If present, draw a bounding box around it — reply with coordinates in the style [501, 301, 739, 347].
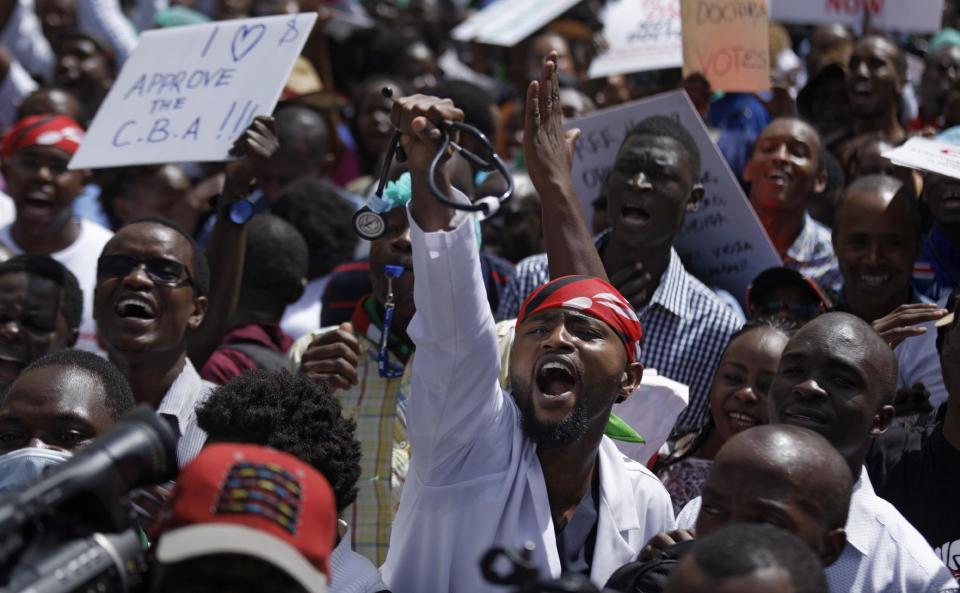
[517, 276, 643, 362]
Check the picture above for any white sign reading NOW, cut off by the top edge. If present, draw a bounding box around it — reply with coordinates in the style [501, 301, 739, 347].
[768, 0, 943, 33]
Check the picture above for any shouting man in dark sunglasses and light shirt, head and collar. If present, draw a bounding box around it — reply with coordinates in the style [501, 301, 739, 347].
[94, 217, 215, 466]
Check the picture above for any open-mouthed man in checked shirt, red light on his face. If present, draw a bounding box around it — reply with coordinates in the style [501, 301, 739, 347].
[743, 117, 840, 290]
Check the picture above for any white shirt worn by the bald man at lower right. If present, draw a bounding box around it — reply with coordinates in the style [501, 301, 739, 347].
[677, 468, 958, 593]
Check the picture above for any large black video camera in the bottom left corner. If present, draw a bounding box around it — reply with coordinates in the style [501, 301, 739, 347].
[0, 405, 177, 593]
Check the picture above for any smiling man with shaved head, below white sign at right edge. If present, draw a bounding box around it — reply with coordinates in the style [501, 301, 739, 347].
[833, 175, 947, 409]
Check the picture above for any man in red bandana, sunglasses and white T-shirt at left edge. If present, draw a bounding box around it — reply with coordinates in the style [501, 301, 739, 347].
[0, 114, 113, 354]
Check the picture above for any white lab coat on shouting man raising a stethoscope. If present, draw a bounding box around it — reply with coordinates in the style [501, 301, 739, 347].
[382, 208, 674, 593]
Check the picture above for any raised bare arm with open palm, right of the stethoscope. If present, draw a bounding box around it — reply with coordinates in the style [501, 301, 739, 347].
[523, 52, 607, 280]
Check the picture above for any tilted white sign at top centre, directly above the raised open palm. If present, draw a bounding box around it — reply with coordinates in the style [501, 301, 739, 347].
[451, 0, 579, 47]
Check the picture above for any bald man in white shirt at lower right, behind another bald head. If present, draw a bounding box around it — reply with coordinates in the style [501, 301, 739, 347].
[756, 312, 957, 593]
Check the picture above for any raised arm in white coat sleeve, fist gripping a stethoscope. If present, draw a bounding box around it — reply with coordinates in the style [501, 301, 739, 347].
[392, 95, 516, 485]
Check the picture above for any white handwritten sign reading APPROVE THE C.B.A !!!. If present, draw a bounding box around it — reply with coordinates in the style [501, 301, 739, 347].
[70, 13, 317, 169]
